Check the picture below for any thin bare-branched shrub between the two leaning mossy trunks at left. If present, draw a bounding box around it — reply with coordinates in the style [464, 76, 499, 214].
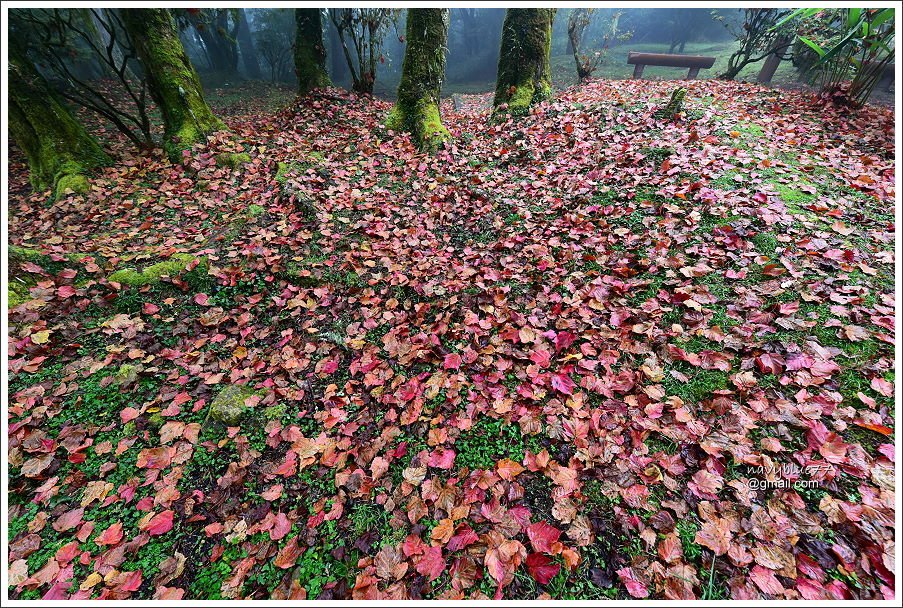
[10, 8, 154, 148]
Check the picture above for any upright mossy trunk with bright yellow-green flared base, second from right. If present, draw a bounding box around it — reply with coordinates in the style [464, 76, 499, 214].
[386, 8, 449, 149]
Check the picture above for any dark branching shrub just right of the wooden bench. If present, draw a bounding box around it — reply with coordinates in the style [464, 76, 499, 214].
[713, 8, 792, 80]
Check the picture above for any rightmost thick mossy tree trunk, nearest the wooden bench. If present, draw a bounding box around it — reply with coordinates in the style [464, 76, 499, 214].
[493, 8, 556, 116]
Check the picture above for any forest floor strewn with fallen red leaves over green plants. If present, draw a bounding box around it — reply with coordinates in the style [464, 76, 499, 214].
[8, 80, 895, 599]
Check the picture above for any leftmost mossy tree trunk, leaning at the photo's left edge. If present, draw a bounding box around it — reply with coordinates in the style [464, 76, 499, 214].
[8, 43, 110, 198]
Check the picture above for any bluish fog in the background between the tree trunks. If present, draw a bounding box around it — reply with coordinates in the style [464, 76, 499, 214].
[181, 8, 741, 98]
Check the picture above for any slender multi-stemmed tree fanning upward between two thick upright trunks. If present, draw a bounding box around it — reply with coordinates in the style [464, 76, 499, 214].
[329, 8, 401, 94]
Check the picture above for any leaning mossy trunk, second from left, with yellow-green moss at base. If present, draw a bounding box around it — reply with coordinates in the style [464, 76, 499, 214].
[122, 8, 225, 162]
